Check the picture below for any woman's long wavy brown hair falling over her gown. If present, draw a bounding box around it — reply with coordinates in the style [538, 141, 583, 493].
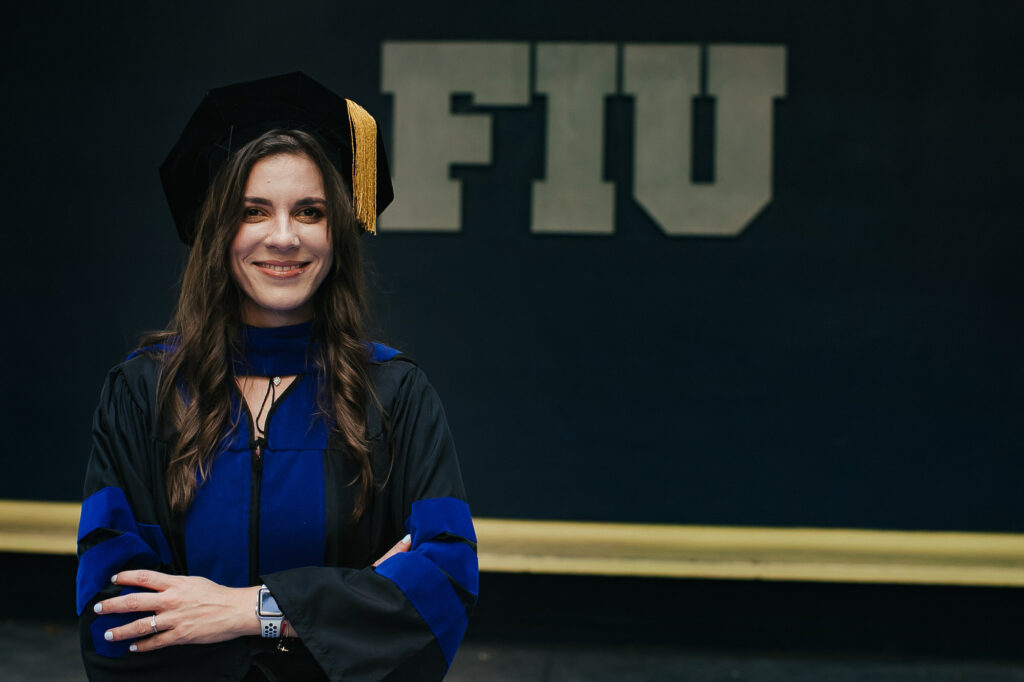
[139, 130, 377, 520]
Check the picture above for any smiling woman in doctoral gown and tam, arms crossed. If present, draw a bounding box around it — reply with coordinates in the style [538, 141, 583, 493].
[78, 74, 477, 681]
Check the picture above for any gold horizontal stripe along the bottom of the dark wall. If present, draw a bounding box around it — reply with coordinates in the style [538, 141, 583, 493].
[8, 500, 1024, 587]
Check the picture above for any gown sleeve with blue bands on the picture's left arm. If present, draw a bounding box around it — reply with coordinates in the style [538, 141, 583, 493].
[76, 358, 250, 681]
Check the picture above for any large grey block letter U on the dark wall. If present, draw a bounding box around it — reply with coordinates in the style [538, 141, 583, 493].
[624, 45, 785, 237]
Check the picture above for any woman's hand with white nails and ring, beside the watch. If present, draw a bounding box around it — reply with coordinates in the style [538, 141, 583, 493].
[94, 570, 260, 651]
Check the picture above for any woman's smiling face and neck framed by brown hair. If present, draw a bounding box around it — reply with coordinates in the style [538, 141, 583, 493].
[229, 154, 333, 327]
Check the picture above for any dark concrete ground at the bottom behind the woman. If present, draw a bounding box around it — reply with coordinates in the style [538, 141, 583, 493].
[6, 621, 1024, 682]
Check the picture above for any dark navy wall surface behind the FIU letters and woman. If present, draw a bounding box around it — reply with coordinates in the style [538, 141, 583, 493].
[0, 0, 1024, 531]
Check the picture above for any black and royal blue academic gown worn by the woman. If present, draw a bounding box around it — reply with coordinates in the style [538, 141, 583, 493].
[77, 325, 477, 682]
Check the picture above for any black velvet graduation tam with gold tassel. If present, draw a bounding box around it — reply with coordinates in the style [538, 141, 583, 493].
[160, 72, 394, 245]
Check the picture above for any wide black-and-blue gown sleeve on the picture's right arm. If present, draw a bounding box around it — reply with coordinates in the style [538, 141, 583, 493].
[261, 367, 478, 680]
